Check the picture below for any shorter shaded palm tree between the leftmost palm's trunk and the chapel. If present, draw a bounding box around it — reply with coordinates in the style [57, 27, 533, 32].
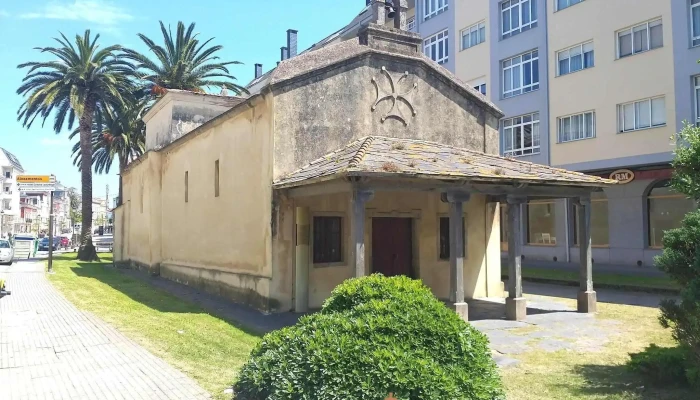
[70, 98, 148, 204]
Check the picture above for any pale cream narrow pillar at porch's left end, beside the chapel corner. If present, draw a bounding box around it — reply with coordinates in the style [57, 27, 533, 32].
[294, 207, 311, 312]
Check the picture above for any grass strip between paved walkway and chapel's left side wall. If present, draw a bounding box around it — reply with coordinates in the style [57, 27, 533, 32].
[49, 254, 259, 399]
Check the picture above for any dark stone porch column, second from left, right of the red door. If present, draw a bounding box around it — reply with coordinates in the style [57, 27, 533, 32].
[447, 193, 469, 321]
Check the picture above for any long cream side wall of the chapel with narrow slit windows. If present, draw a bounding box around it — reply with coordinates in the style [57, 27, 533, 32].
[118, 94, 274, 309]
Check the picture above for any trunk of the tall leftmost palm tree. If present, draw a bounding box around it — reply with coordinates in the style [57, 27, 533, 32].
[78, 100, 97, 261]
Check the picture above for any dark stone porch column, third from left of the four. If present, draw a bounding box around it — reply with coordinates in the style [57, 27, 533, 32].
[506, 196, 527, 321]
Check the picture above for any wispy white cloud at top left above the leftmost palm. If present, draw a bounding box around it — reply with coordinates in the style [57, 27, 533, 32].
[20, 0, 134, 27]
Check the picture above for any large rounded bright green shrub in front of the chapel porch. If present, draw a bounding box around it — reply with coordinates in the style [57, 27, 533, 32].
[234, 275, 504, 400]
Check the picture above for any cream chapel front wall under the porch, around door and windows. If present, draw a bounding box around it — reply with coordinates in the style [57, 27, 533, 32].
[295, 192, 503, 308]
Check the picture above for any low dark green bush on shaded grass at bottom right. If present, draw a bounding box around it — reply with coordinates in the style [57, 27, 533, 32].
[627, 344, 688, 386]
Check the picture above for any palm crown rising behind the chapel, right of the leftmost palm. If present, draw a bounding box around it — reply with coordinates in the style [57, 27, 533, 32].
[124, 21, 247, 96]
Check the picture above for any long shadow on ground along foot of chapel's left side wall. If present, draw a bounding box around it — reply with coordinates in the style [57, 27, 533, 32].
[64, 257, 298, 336]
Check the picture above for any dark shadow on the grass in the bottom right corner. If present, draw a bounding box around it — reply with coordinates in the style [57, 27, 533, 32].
[559, 364, 700, 400]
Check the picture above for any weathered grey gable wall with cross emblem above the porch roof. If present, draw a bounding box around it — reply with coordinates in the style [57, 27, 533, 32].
[274, 55, 498, 177]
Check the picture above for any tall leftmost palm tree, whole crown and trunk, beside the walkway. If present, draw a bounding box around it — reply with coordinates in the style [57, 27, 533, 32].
[17, 30, 134, 261]
